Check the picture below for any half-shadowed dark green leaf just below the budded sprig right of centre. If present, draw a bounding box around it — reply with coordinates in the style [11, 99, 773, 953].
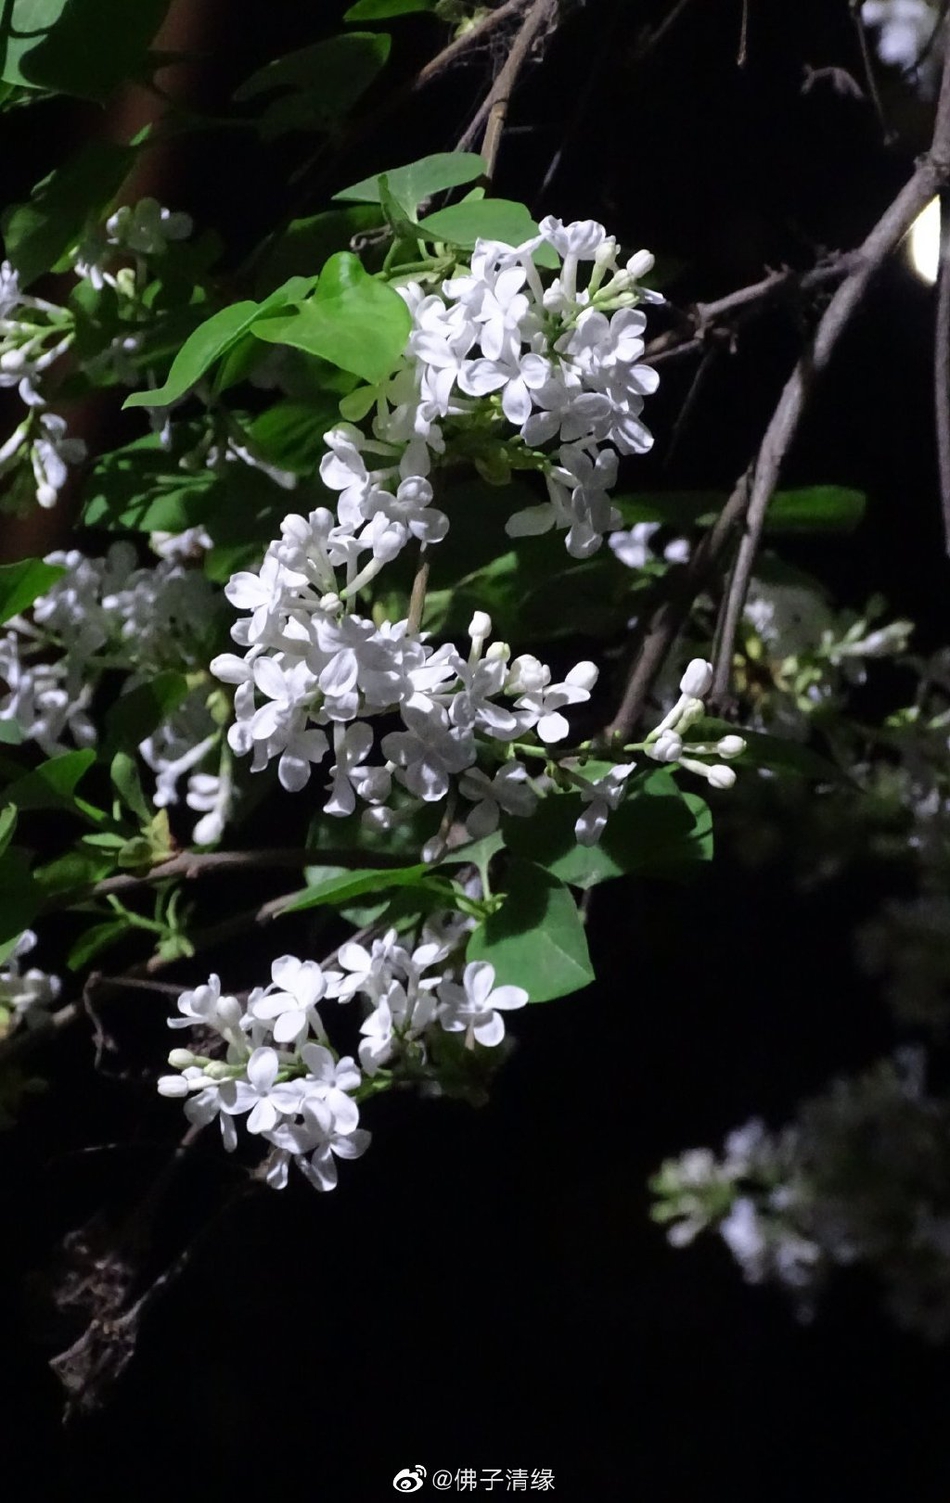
[502, 770, 713, 888]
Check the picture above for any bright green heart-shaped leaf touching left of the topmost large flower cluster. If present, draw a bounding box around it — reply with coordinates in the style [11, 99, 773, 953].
[254, 251, 412, 383]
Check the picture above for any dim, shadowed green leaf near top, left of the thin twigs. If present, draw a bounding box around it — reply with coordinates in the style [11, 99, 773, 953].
[234, 32, 392, 140]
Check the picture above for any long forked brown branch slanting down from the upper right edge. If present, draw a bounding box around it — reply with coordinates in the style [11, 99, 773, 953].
[604, 54, 950, 739]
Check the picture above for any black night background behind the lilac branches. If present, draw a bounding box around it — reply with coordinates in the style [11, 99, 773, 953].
[0, 0, 950, 1503]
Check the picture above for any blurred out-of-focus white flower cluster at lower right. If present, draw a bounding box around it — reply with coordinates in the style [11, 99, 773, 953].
[652, 1049, 950, 1341]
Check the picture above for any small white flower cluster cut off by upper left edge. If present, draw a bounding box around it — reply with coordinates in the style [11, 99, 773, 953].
[0, 262, 86, 507]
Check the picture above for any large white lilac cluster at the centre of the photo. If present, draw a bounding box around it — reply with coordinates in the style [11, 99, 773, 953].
[217, 523, 597, 833]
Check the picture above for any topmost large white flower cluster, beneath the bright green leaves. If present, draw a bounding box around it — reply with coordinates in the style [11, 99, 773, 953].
[322, 216, 663, 558]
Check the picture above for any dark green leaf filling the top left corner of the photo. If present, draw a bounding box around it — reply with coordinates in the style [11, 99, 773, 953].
[0, 0, 168, 99]
